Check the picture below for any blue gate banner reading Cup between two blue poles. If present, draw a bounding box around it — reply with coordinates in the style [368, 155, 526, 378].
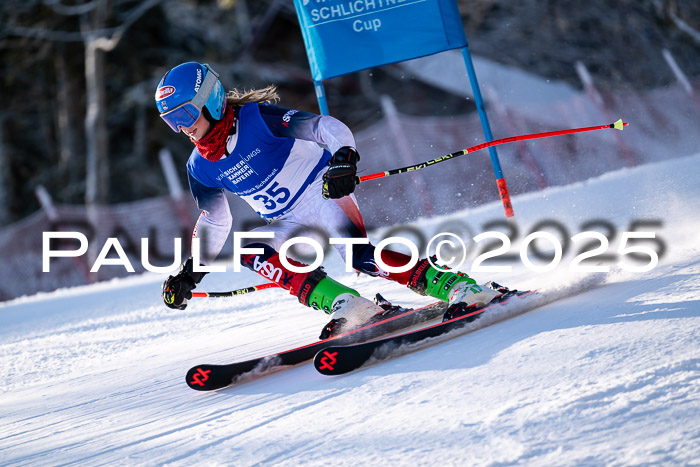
[294, 0, 467, 81]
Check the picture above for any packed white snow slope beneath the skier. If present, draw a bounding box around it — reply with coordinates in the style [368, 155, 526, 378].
[0, 155, 700, 466]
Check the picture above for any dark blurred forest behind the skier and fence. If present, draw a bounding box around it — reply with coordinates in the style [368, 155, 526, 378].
[0, 0, 700, 226]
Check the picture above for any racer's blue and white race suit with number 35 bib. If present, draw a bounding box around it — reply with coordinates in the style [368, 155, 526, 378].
[187, 103, 377, 273]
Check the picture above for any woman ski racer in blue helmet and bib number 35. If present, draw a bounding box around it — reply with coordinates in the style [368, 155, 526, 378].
[155, 62, 501, 337]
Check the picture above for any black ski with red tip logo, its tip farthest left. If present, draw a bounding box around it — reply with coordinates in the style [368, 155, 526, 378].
[185, 302, 446, 391]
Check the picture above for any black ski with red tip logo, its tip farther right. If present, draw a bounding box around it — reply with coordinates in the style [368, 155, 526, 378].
[314, 277, 600, 375]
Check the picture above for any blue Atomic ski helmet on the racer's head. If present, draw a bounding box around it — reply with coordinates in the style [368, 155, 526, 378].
[156, 62, 226, 133]
